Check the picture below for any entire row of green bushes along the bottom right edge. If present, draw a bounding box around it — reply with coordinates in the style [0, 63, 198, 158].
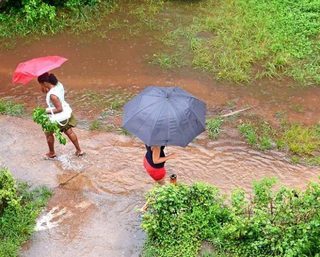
[142, 179, 320, 257]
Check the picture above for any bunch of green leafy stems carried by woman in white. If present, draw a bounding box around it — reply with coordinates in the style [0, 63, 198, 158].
[32, 107, 67, 145]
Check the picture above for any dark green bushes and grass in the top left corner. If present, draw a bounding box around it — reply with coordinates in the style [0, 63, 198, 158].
[0, 0, 116, 48]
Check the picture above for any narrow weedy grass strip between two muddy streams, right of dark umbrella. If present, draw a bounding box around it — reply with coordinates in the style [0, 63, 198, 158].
[207, 114, 320, 166]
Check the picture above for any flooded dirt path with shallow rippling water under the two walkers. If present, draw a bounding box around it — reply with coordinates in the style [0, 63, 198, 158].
[0, 116, 320, 257]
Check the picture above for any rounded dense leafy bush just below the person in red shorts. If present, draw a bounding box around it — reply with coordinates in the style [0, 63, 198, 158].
[142, 184, 229, 257]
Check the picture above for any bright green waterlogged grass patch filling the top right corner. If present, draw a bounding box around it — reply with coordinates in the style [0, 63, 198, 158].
[124, 0, 320, 85]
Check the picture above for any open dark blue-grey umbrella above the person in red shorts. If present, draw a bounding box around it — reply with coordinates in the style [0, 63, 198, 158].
[122, 86, 206, 147]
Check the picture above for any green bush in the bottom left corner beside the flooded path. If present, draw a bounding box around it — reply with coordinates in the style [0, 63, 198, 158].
[0, 168, 51, 257]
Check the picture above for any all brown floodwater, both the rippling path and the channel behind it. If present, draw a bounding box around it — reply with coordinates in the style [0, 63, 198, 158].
[0, 19, 320, 257]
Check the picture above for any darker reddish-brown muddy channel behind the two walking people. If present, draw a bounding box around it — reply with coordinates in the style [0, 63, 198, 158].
[0, 29, 320, 124]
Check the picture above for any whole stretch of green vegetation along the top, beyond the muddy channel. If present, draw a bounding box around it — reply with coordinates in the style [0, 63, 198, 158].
[0, 0, 320, 85]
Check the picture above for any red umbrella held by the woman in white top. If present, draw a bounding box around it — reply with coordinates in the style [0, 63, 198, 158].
[12, 56, 68, 85]
